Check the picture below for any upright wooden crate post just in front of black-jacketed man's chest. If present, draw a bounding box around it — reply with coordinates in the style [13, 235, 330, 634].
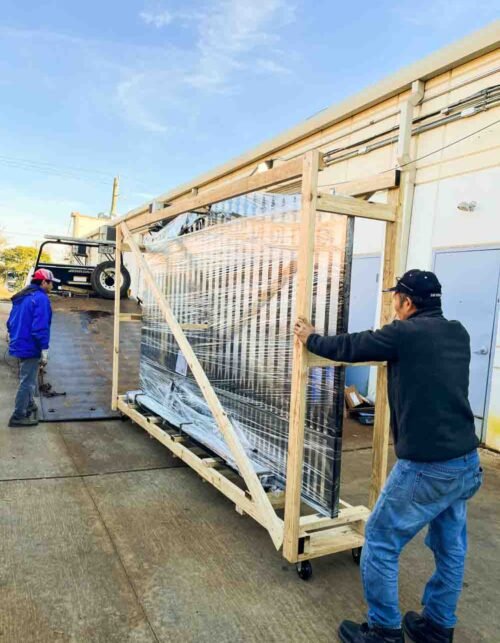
[368, 188, 400, 509]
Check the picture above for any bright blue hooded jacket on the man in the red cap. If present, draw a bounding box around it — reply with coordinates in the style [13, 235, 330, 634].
[7, 284, 52, 359]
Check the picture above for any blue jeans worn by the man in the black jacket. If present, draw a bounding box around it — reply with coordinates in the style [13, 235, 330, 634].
[361, 450, 482, 629]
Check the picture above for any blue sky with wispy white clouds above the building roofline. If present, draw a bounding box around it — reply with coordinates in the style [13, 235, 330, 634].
[0, 0, 499, 245]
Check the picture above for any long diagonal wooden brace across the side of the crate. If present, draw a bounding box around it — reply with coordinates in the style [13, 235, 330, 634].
[121, 223, 283, 548]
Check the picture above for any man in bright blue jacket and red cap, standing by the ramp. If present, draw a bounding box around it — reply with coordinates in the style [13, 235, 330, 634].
[7, 268, 59, 427]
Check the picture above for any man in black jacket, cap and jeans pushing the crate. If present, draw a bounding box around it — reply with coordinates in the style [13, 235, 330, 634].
[295, 270, 482, 643]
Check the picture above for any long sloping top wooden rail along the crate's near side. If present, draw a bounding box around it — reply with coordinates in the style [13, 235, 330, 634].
[118, 157, 302, 231]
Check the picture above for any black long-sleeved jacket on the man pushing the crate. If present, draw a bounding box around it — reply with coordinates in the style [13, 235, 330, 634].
[307, 309, 478, 462]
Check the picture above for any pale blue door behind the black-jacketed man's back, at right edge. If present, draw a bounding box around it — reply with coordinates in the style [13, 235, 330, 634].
[434, 249, 500, 438]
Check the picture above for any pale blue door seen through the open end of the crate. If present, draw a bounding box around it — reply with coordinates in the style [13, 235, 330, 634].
[346, 255, 380, 395]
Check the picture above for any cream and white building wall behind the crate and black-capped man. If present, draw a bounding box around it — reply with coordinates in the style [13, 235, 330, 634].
[316, 51, 500, 450]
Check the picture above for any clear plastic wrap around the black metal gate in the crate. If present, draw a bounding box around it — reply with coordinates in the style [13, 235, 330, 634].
[138, 192, 352, 516]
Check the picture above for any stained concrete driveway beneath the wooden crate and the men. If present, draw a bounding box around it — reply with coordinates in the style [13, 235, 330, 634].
[0, 304, 500, 643]
